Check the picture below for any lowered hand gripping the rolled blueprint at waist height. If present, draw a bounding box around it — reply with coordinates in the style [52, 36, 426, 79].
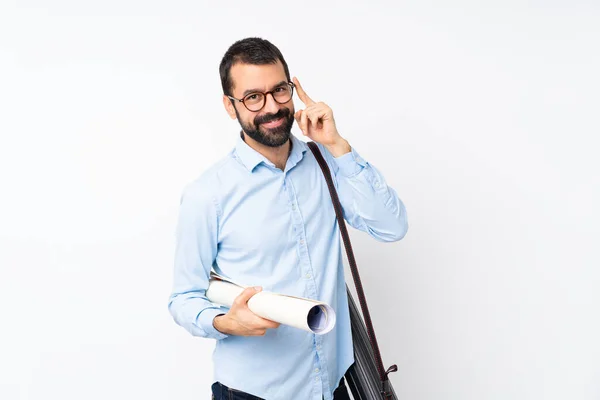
[213, 287, 280, 336]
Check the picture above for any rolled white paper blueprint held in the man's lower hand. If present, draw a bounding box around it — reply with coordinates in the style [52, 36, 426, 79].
[206, 273, 335, 335]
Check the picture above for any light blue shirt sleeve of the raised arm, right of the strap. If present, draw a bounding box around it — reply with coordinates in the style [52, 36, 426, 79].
[319, 144, 408, 242]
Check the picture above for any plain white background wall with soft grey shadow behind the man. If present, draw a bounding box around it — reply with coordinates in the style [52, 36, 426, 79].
[0, 0, 600, 400]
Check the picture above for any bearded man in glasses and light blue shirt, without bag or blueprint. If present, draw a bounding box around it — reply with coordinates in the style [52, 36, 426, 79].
[169, 38, 408, 400]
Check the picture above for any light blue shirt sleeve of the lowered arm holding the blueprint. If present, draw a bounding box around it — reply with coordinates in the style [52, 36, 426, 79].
[169, 181, 228, 340]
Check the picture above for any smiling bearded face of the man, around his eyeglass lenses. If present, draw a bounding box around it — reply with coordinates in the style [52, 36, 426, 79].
[224, 61, 294, 147]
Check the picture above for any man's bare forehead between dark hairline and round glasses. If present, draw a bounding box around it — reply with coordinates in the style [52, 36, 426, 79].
[230, 61, 287, 93]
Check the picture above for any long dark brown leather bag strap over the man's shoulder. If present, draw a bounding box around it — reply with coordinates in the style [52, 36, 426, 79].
[307, 142, 398, 390]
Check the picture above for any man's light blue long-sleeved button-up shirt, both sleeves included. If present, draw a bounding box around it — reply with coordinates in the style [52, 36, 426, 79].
[169, 135, 408, 400]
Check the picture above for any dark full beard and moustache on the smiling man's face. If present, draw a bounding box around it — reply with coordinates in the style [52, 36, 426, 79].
[235, 108, 294, 147]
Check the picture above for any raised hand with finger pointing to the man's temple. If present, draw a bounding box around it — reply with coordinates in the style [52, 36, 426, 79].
[293, 77, 344, 147]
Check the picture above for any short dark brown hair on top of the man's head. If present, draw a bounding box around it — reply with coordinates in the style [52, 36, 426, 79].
[219, 37, 290, 96]
